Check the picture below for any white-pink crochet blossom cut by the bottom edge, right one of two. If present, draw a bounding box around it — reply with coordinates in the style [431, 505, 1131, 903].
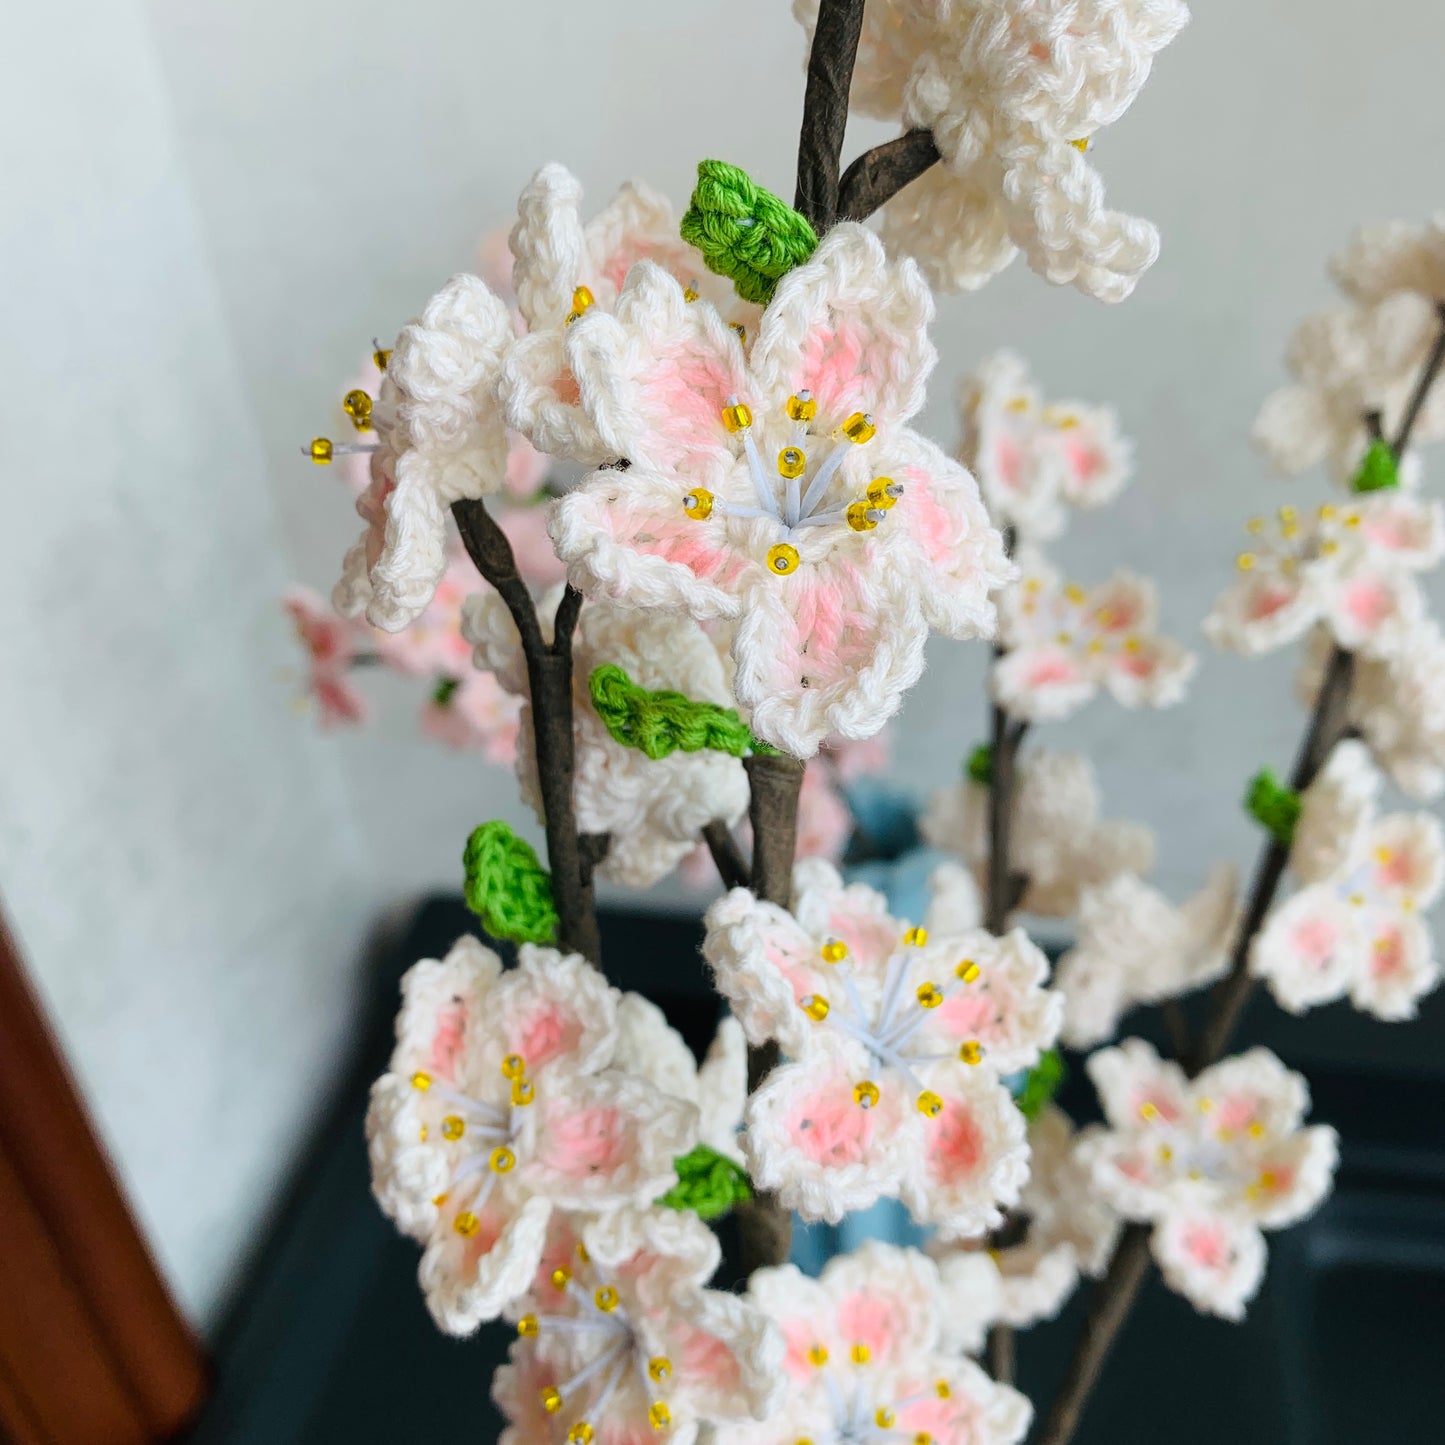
[717, 1240, 1032, 1445]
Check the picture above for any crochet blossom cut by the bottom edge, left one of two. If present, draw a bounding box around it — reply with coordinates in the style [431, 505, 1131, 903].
[493, 1209, 786, 1445]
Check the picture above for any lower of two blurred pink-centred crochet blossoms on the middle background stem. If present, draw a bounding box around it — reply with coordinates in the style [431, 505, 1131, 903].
[991, 549, 1198, 721]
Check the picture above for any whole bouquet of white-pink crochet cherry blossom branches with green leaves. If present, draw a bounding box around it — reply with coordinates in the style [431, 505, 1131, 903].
[288, 0, 1445, 1445]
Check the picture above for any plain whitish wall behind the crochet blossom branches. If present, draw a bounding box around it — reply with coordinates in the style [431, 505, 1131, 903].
[0, 0, 1445, 1321]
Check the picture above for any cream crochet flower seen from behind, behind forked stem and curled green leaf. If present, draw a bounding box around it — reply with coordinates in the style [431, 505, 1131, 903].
[464, 590, 749, 889]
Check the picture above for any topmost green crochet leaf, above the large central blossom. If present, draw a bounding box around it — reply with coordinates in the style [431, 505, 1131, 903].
[679, 160, 818, 306]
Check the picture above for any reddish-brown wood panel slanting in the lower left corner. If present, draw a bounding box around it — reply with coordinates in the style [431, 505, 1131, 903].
[0, 916, 208, 1445]
